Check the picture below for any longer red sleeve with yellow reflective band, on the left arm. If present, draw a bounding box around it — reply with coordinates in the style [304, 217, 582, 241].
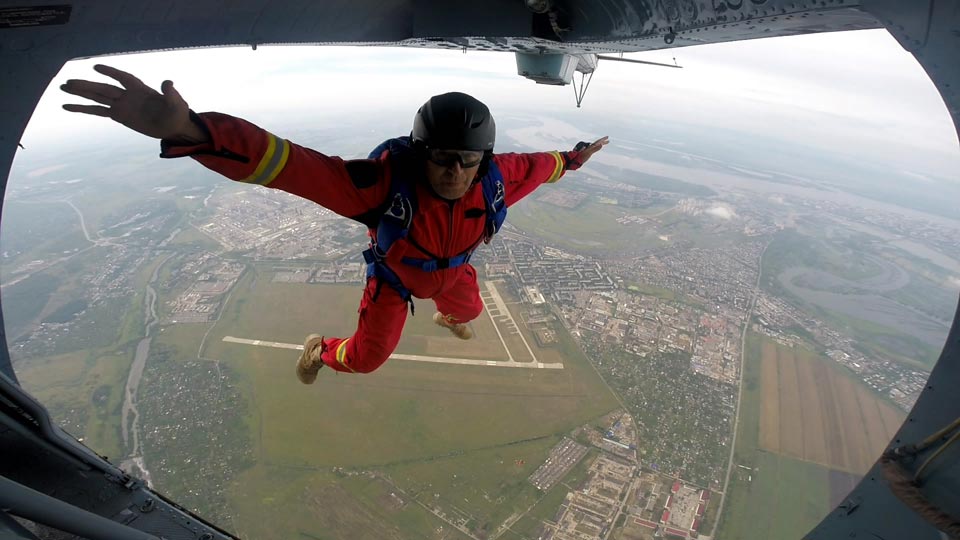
[160, 113, 390, 219]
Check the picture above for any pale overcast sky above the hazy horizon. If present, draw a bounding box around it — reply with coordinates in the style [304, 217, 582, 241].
[23, 30, 960, 181]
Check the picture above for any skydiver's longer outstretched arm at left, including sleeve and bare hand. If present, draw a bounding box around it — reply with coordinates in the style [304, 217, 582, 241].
[61, 65, 389, 222]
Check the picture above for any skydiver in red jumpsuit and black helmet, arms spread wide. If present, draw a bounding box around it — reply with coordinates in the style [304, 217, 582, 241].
[60, 65, 608, 384]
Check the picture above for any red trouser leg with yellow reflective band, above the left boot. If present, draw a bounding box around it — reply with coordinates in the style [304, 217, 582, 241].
[320, 277, 407, 373]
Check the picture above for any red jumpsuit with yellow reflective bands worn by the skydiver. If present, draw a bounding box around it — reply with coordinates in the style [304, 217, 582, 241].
[161, 113, 579, 373]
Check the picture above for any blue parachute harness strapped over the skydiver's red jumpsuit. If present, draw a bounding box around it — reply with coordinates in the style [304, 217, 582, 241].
[363, 137, 507, 315]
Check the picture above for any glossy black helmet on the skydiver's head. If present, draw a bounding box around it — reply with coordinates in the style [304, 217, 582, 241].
[410, 92, 497, 152]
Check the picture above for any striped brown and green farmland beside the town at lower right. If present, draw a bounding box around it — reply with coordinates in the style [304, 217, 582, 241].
[716, 332, 903, 540]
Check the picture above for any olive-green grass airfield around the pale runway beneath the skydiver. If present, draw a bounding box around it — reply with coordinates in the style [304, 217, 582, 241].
[203, 272, 617, 538]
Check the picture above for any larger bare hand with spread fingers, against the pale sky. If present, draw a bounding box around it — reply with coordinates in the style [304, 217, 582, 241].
[60, 64, 208, 143]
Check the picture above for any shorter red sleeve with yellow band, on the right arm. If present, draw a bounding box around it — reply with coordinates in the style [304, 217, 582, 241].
[493, 152, 580, 206]
